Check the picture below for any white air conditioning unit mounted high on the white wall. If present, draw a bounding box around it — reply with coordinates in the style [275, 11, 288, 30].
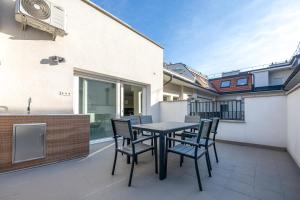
[15, 0, 67, 40]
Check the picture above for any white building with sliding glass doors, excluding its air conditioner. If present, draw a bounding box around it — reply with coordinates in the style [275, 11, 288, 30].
[0, 0, 163, 139]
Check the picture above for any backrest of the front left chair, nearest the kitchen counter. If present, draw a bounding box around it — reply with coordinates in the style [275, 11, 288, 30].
[111, 119, 133, 140]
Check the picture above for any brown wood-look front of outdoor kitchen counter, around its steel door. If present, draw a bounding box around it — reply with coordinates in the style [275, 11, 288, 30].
[0, 114, 90, 172]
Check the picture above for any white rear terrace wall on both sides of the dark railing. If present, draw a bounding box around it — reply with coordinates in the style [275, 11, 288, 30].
[160, 96, 286, 147]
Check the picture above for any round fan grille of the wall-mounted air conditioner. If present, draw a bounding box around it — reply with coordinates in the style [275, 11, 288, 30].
[21, 0, 51, 20]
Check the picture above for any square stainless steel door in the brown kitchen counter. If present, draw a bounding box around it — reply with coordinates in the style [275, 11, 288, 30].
[13, 123, 47, 163]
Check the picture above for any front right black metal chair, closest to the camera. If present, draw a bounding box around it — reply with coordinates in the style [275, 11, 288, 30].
[166, 120, 212, 191]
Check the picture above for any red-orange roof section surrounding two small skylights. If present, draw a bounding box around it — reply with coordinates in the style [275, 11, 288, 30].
[210, 74, 252, 93]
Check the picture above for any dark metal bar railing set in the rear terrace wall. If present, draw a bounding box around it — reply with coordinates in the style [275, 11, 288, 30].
[189, 100, 245, 121]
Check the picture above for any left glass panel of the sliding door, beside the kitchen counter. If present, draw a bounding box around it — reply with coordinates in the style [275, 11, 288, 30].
[79, 78, 117, 140]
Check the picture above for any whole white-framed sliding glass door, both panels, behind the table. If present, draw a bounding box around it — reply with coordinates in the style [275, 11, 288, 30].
[73, 76, 147, 140]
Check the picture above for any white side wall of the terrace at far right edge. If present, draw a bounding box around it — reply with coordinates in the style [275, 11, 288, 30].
[287, 87, 300, 167]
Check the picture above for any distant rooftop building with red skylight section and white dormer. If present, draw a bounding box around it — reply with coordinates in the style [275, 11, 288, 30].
[209, 55, 300, 94]
